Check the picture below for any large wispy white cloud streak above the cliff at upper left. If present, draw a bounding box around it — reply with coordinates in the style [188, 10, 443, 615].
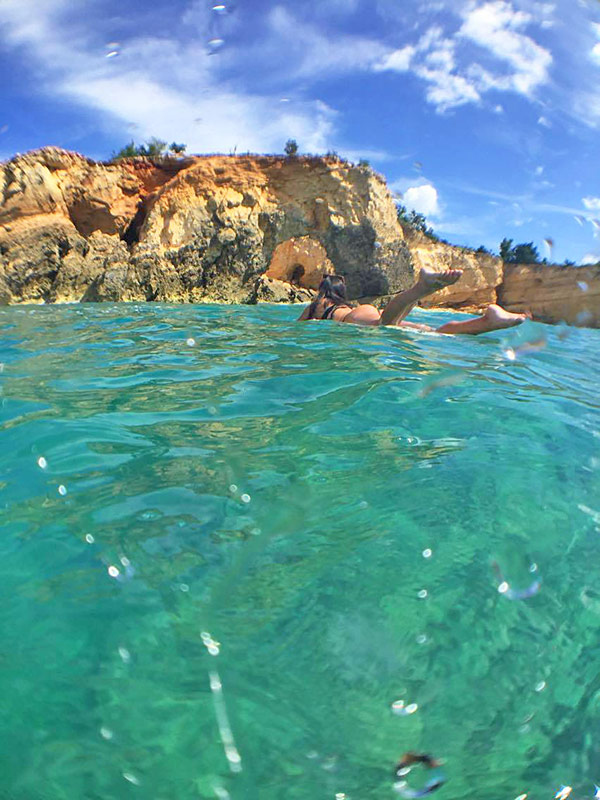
[0, 0, 339, 153]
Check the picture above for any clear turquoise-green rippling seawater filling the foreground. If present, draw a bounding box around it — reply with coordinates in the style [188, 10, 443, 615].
[0, 305, 600, 800]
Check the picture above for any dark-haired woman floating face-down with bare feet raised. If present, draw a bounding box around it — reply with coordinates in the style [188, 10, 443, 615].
[298, 269, 528, 335]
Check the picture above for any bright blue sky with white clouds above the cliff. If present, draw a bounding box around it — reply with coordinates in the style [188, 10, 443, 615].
[0, 0, 600, 263]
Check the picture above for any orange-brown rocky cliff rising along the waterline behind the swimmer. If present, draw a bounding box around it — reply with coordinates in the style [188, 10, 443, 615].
[0, 147, 600, 326]
